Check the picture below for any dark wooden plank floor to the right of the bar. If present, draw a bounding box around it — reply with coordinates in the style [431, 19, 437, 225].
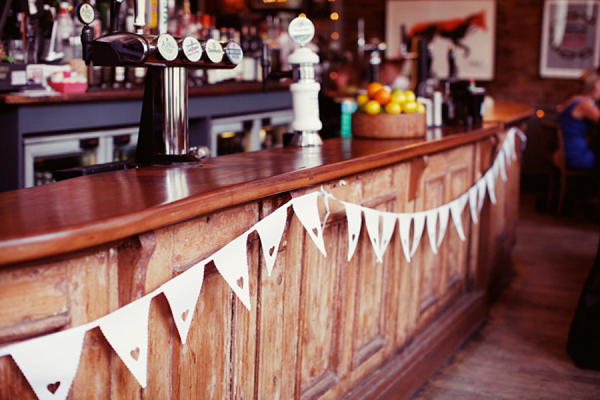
[413, 194, 600, 399]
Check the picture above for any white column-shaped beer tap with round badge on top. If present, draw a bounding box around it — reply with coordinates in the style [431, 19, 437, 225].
[287, 17, 323, 146]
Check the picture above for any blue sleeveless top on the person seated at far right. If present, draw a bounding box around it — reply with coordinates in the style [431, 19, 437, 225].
[558, 99, 596, 169]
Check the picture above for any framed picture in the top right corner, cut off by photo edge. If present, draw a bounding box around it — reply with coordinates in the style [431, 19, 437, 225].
[540, 0, 600, 79]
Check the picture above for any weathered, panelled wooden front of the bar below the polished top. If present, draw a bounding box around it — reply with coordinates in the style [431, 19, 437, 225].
[0, 130, 518, 399]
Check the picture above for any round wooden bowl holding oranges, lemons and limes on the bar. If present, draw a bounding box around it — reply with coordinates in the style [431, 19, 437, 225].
[352, 112, 427, 139]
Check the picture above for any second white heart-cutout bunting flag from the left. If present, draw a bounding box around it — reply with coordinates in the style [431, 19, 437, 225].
[98, 294, 153, 388]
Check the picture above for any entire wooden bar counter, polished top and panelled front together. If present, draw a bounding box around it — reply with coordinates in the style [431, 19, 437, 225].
[0, 104, 532, 399]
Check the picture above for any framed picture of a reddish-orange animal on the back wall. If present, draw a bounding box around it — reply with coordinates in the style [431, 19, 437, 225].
[385, 0, 496, 81]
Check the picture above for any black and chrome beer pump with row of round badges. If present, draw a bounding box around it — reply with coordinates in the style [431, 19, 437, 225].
[77, 0, 243, 166]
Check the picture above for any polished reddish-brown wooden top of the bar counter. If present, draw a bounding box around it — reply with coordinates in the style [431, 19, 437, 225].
[0, 104, 533, 265]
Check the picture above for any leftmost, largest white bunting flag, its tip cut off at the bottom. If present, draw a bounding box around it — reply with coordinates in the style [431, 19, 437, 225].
[10, 325, 87, 400]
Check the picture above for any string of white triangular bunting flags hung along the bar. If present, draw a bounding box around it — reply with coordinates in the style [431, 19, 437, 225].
[0, 128, 526, 400]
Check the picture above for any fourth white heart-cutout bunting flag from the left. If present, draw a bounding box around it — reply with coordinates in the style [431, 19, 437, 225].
[212, 233, 250, 310]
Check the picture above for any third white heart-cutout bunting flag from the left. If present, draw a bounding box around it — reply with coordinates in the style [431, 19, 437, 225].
[162, 261, 206, 344]
